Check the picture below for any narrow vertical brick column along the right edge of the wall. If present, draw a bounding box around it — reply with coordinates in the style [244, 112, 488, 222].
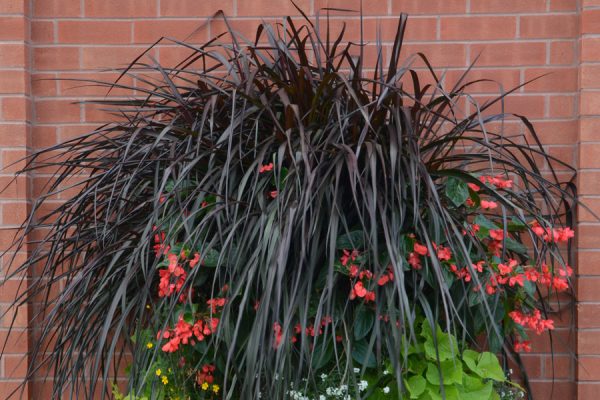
[577, 0, 600, 399]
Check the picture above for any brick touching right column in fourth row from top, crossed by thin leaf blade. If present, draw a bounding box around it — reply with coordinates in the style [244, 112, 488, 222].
[525, 68, 578, 92]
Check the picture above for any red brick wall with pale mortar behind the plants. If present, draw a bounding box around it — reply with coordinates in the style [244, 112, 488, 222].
[0, 0, 600, 400]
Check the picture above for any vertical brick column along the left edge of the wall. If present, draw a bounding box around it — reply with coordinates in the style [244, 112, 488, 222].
[0, 0, 31, 399]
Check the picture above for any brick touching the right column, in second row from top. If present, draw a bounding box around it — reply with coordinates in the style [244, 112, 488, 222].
[520, 14, 578, 39]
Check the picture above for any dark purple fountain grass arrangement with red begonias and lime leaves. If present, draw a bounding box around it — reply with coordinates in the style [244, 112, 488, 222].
[2, 9, 575, 400]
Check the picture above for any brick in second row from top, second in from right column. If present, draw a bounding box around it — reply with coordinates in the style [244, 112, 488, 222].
[440, 16, 517, 40]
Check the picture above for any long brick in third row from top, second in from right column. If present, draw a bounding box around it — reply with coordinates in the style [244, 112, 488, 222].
[471, 42, 546, 66]
